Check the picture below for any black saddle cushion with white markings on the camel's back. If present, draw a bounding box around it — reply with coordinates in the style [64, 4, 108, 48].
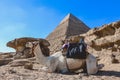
[66, 43, 87, 59]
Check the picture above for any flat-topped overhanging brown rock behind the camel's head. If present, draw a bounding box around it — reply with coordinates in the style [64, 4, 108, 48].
[6, 37, 50, 59]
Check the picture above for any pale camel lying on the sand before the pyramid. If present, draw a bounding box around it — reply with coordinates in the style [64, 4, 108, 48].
[26, 41, 102, 74]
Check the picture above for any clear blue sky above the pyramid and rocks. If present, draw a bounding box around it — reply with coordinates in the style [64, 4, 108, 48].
[0, 0, 120, 52]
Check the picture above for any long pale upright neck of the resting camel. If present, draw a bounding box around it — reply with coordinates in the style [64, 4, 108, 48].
[34, 44, 48, 64]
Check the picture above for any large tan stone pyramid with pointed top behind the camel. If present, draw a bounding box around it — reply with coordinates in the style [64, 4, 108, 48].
[46, 14, 90, 52]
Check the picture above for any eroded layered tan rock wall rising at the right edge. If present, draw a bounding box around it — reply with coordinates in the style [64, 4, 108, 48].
[70, 21, 120, 63]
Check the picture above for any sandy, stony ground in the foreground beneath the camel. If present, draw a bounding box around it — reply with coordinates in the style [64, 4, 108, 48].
[0, 63, 120, 80]
